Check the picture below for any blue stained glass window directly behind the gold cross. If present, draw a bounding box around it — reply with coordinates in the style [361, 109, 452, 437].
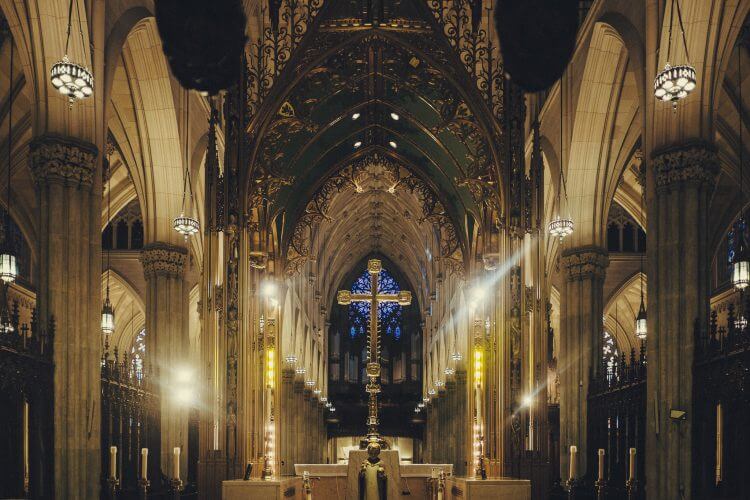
[349, 269, 401, 340]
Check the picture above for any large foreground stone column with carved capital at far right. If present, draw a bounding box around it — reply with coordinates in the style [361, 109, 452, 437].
[646, 144, 719, 499]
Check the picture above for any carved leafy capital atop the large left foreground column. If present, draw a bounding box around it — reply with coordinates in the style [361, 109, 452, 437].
[29, 134, 99, 187]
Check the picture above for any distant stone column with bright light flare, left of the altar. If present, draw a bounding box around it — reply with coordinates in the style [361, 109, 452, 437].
[141, 243, 189, 481]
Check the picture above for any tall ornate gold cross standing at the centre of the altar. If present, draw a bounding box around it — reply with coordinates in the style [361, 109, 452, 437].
[336, 259, 411, 445]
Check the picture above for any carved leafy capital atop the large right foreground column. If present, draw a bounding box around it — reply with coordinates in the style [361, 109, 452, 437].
[651, 142, 719, 191]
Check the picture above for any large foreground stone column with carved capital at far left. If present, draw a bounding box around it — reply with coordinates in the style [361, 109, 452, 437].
[29, 135, 102, 499]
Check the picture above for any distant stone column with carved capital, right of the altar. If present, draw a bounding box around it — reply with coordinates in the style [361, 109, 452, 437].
[558, 246, 609, 481]
